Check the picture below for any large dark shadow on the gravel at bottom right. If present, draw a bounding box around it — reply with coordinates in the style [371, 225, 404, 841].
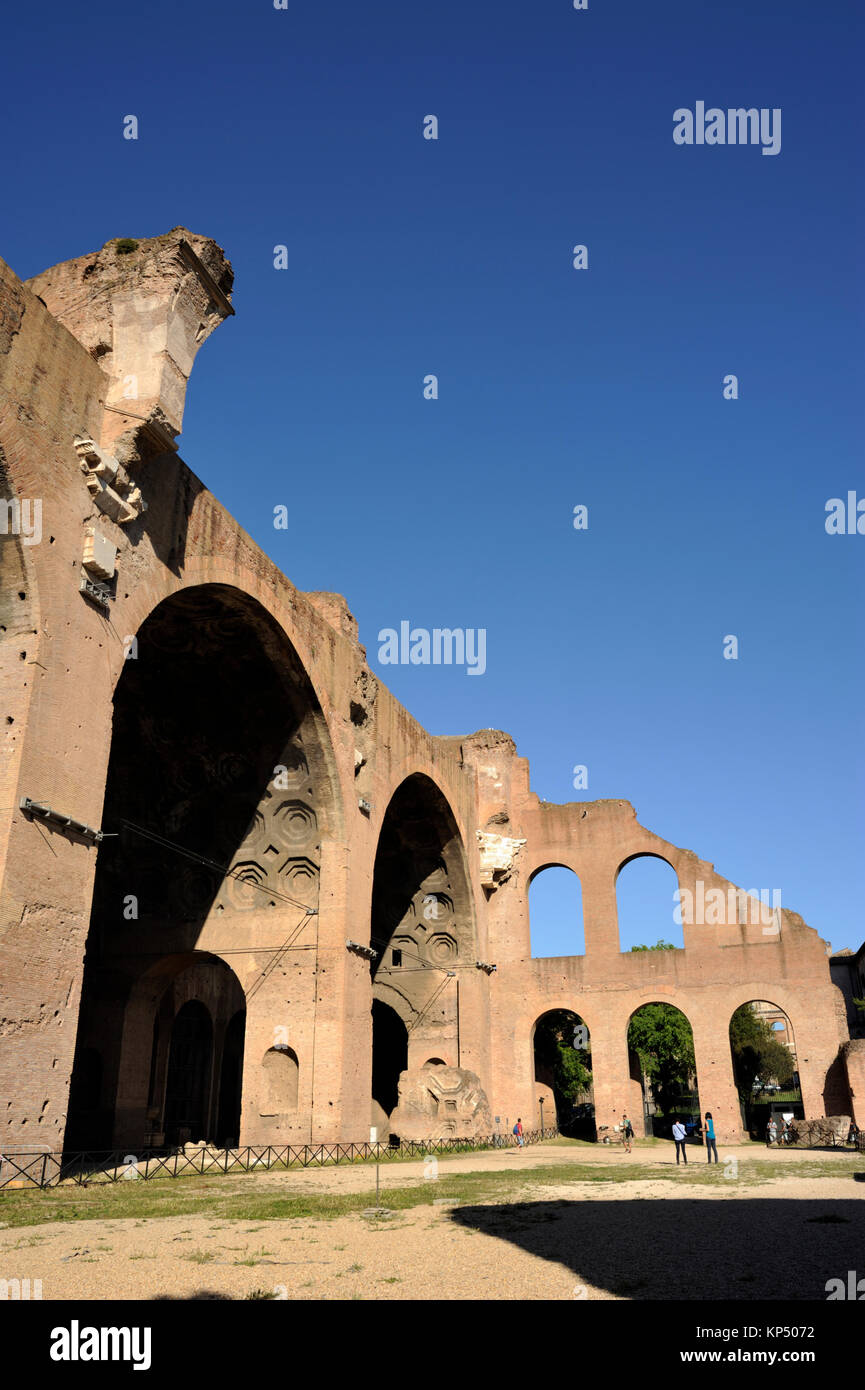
[451, 1197, 865, 1301]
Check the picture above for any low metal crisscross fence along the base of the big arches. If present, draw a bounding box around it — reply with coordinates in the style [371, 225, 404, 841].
[0, 1126, 559, 1191]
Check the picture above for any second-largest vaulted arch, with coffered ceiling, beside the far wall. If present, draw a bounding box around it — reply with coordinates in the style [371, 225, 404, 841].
[370, 773, 477, 1129]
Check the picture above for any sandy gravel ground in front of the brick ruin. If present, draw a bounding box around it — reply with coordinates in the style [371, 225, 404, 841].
[0, 1145, 865, 1301]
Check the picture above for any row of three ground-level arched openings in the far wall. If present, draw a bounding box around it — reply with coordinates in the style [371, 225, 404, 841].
[531, 999, 804, 1140]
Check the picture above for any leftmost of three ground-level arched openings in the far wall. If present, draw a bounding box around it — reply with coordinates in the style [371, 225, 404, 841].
[531, 1009, 595, 1138]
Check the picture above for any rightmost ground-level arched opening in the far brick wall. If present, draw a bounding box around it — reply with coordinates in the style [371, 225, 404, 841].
[730, 999, 805, 1140]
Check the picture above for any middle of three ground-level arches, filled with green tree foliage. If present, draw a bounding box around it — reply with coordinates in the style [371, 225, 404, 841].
[627, 1002, 701, 1140]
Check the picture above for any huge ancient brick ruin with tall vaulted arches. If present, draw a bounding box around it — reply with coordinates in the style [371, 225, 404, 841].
[0, 228, 865, 1152]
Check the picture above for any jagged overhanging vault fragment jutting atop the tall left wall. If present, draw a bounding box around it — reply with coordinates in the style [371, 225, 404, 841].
[26, 227, 234, 457]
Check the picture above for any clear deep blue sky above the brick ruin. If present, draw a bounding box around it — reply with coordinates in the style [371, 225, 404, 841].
[0, 0, 865, 949]
